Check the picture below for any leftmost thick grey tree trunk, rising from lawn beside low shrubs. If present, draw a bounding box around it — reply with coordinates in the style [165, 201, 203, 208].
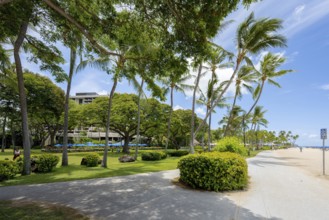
[14, 21, 31, 175]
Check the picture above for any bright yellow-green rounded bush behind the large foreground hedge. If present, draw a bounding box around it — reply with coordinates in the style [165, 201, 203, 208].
[214, 137, 248, 156]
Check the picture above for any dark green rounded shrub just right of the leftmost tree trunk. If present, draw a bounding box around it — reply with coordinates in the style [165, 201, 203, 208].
[31, 154, 59, 173]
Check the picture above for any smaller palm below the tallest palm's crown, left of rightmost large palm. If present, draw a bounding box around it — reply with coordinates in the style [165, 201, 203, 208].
[224, 66, 257, 136]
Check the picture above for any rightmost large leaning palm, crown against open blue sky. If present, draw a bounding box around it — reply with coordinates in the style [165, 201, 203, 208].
[246, 53, 292, 116]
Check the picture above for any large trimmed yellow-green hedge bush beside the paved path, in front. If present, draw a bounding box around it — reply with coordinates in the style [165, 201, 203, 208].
[178, 152, 248, 191]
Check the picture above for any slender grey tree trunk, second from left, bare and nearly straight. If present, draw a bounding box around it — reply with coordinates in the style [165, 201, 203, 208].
[62, 47, 76, 166]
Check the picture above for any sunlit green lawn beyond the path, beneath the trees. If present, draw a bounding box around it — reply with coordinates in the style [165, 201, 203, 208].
[0, 150, 179, 186]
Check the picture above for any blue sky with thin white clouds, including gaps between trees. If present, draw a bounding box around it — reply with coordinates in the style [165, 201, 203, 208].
[23, 0, 329, 146]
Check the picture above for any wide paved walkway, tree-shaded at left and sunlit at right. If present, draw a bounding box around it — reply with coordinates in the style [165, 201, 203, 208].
[0, 152, 329, 220]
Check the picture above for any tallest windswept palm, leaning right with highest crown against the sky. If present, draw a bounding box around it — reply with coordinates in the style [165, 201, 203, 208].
[195, 13, 286, 136]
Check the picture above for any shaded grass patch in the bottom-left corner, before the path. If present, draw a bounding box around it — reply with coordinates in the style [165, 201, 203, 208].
[0, 201, 89, 220]
